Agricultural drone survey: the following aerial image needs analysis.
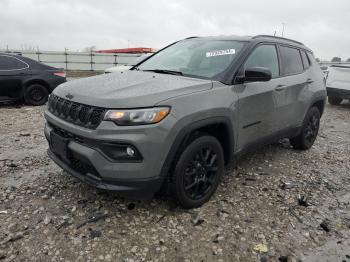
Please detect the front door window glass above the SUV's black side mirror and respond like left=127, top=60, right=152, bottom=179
left=244, top=45, right=279, bottom=78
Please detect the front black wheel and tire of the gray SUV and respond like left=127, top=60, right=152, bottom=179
left=169, top=135, right=224, bottom=208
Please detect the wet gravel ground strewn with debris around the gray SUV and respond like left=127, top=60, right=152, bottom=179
left=0, top=103, right=350, bottom=262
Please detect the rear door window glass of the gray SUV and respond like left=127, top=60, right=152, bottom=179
left=280, top=46, right=304, bottom=75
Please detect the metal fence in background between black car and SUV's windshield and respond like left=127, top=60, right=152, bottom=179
left=0, top=50, right=141, bottom=71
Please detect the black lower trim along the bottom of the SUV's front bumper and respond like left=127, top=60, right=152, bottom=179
left=47, top=149, right=163, bottom=199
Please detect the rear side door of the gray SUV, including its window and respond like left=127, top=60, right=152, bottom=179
left=275, top=45, right=313, bottom=132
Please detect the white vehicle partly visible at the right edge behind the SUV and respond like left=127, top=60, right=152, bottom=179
left=326, top=64, right=350, bottom=105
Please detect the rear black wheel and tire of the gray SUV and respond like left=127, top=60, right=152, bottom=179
left=290, top=107, right=321, bottom=150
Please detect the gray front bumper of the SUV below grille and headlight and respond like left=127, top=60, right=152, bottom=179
left=44, top=111, right=178, bottom=198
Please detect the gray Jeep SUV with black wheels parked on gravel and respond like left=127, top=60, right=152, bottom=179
left=45, top=36, right=326, bottom=208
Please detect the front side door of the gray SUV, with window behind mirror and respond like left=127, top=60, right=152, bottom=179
left=235, top=44, right=283, bottom=150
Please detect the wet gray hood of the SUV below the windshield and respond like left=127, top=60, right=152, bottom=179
left=53, top=71, right=212, bottom=108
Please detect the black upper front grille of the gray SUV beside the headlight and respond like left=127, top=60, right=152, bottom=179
left=48, top=94, right=105, bottom=129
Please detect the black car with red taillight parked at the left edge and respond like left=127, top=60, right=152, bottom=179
left=0, top=53, right=66, bottom=105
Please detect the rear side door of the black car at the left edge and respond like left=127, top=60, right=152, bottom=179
left=0, top=54, right=30, bottom=100
